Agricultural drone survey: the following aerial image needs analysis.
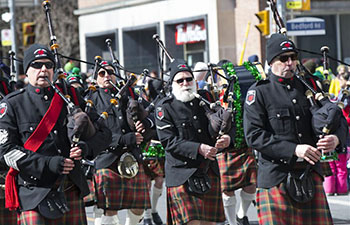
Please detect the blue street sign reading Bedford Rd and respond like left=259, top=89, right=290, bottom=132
left=287, top=17, right=326, bottom=36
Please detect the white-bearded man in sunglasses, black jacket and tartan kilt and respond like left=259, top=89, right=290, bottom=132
left=155, top=59, right=233, bottom=225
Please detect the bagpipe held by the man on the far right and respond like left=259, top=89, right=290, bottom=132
left=268, top=0, right=343, bottom=161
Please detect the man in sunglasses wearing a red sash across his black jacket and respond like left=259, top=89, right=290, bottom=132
left=0, top=44, right=111, bottom=224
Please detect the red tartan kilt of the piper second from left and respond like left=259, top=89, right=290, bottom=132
left=94, top=165, right=151, bottom=210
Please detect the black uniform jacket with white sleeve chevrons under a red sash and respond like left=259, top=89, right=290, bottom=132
left=0, top=85, right=111, bottom=210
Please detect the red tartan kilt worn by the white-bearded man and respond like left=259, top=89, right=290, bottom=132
left=167, top=169, right=225, bottom=224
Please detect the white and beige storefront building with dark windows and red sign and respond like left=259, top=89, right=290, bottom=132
left=75, top=0, right=261, bottom=72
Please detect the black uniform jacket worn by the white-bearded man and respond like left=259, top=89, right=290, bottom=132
left=155, top=90, right=227, bottom=187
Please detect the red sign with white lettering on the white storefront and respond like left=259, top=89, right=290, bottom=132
left=175, top=20, right=207, bottom=45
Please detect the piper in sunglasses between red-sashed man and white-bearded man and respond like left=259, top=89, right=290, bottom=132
left=87, top=61, right=155, bottom=225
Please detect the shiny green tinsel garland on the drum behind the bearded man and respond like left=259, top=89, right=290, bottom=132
left=223, top=62, right=261, bottom=149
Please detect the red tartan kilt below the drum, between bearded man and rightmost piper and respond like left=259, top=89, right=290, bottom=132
left=216, top=148, right=257, bottom=191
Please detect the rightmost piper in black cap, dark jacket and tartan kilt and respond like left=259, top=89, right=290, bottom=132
left=243, top=34, right=347, bottom=224
